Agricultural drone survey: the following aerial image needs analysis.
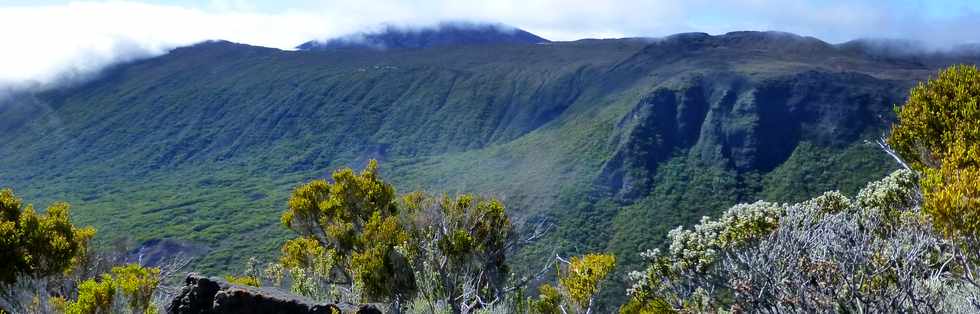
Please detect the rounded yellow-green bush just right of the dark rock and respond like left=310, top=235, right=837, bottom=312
left=281, top=160, right=415, bottom=301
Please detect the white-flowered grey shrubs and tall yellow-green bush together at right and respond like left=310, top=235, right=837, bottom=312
left=621, top=66, right=980, bottom=313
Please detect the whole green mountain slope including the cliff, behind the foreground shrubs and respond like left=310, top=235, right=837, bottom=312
left=0, top=32, right=968, bottom=280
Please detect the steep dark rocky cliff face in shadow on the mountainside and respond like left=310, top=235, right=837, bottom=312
left=598, top=71, right=907, bottom=201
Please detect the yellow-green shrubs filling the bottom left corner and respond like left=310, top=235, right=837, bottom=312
left=0, top=189, right=186, bottom=314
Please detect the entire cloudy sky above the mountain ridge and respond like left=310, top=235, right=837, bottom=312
left=0, top=0, right=980, bottom=91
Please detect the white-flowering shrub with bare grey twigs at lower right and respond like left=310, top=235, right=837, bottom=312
left=628, top=170, right=968, bottom=312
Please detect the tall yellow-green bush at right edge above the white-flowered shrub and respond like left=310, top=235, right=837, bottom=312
left=888, top=65, right=980, bottom=304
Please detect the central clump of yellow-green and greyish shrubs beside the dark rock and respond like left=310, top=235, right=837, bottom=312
left=228, top=161, right=615, bottom=313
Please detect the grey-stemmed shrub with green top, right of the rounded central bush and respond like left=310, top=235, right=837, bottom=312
left=401, top=192, right=514, bottom=313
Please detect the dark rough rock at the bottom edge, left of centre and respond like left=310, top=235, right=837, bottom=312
left=167, top=273, right=366, bottom=314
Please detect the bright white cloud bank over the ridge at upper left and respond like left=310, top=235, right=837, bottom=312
left=0, top=2, right=338, bottom=88
